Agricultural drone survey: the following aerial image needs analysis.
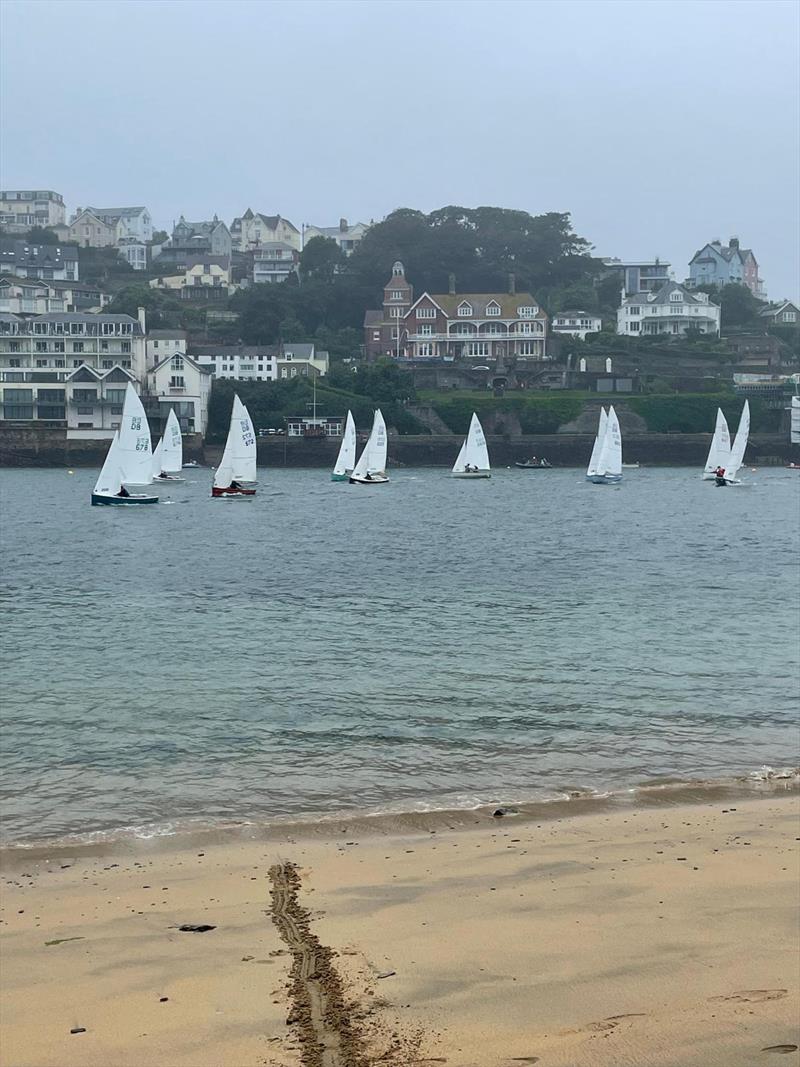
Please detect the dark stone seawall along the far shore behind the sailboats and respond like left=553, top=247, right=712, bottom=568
left=0, top=428, right=800, bottom=467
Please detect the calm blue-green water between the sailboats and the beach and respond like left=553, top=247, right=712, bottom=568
left=0, top=468, right=800, bottom=841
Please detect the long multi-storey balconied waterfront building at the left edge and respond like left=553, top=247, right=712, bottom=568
left=0, top=309, right=145, bottom=437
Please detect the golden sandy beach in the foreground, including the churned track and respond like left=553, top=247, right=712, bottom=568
left=0, top=793, right=800, bottom=1067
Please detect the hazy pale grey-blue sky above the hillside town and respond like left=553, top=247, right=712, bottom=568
left=0, top=0, right=800, bottom=299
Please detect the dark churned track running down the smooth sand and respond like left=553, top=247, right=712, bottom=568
left=269, top=863, right=369, bottom=1067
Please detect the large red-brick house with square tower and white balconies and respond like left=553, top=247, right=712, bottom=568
left=364, top=261, right=547, bottom=361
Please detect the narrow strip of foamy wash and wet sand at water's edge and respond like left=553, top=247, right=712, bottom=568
left=0, top=766, right=800, bottom=866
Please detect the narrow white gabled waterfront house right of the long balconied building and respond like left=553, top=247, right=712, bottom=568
left=143, top=349, right=212, bottom=434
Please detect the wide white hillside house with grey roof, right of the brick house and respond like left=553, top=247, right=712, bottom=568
left=617, top=282, right=720, bottom=337
